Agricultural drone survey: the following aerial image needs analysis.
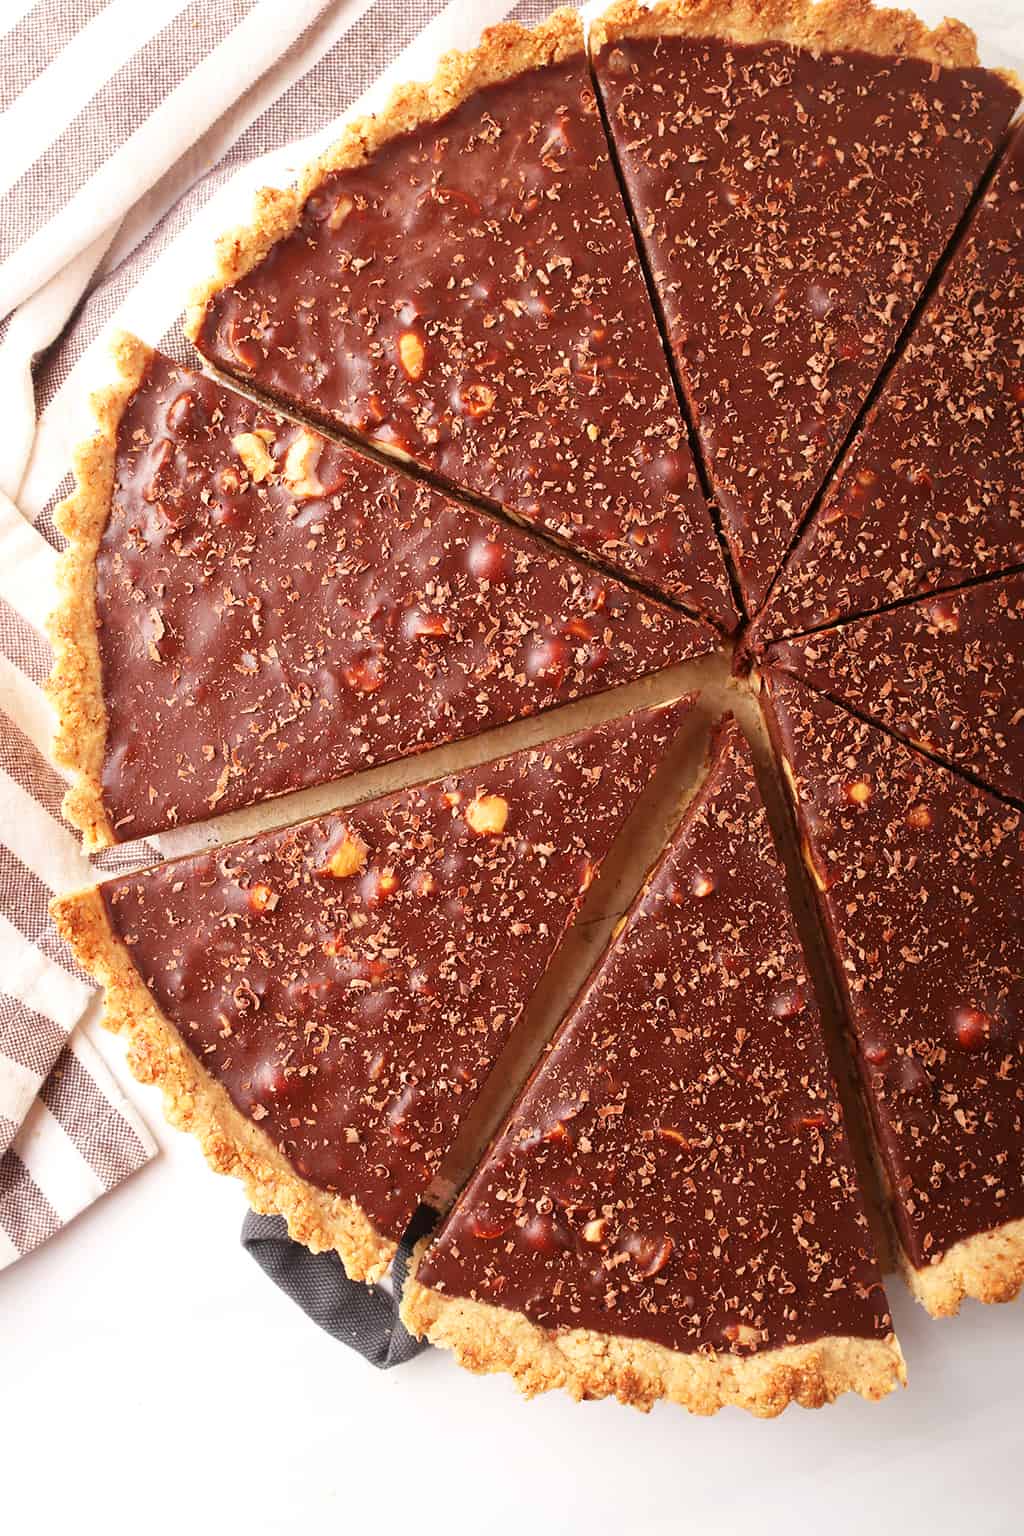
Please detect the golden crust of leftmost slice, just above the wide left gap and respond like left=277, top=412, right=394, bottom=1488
left=46, top=330, right=154, bottom=854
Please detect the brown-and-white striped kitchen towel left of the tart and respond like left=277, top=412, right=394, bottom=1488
left=0, top=0, right=577, bottom=1267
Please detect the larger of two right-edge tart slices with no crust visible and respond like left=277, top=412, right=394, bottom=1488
left=760, top=127, right=1024, bottom=636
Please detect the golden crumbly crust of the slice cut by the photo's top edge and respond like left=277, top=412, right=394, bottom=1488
left=590, top=0, right=978, bottom=69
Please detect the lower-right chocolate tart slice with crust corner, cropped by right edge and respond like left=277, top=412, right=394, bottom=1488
left=766, top=670, right=1024, bottom=1316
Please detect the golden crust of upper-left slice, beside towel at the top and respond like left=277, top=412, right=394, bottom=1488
left=184, top=8, right=585, bottom=344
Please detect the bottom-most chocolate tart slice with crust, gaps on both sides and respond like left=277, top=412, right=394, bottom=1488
left=402, top=722, right=904, bottom=1416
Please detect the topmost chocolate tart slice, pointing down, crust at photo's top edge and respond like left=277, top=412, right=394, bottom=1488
left=591, top=0, right=1018, bottom=614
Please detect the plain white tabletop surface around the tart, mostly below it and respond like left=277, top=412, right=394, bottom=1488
left=0, top=0, right=1024, bottom=1536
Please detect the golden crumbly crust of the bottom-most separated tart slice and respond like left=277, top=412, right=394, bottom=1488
left=401, top=1238, right=906, bottom=1419
